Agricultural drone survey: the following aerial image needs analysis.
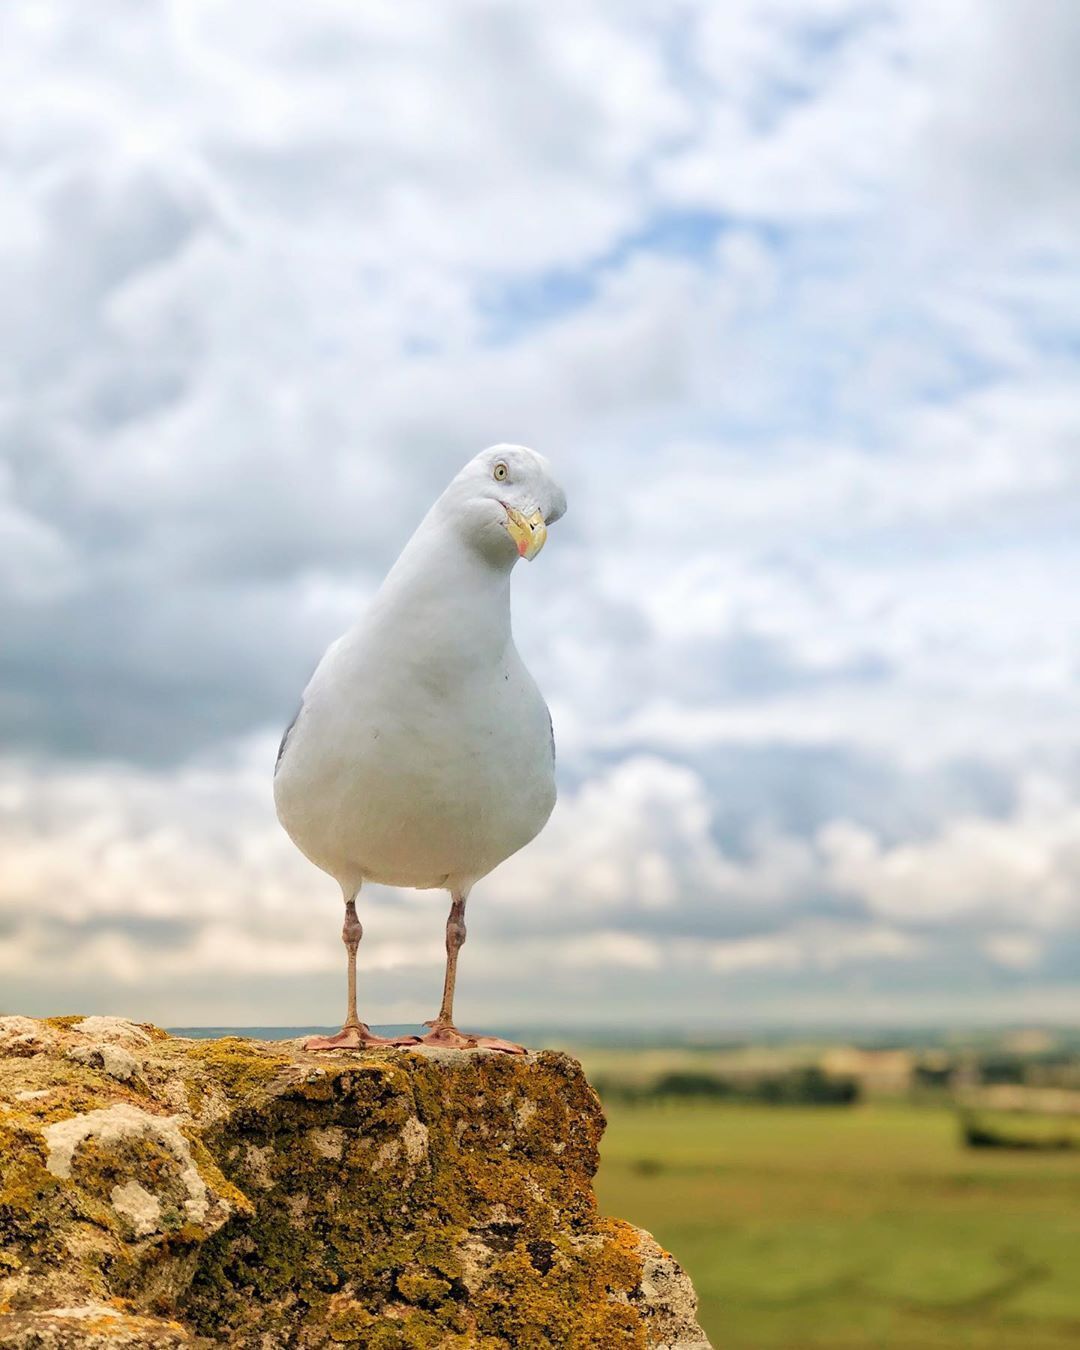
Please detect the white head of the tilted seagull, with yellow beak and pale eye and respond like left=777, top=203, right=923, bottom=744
left=444, top=446, right=566, bottom=566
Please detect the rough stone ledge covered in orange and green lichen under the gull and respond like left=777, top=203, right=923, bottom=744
left=0, top=1018, right=707, bottom=1350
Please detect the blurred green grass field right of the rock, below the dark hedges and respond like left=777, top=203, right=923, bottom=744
left=598, top=1104, right=1080, bottom=1350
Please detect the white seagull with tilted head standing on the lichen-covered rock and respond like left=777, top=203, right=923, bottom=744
left=274, top=446, right=566, bottom=1054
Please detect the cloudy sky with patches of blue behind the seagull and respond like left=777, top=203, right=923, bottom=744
left=0, top=0, right=1080, bottom=1031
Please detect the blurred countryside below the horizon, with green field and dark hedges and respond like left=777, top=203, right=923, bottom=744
left=173, top=1026, right=1080, bottom=1350
